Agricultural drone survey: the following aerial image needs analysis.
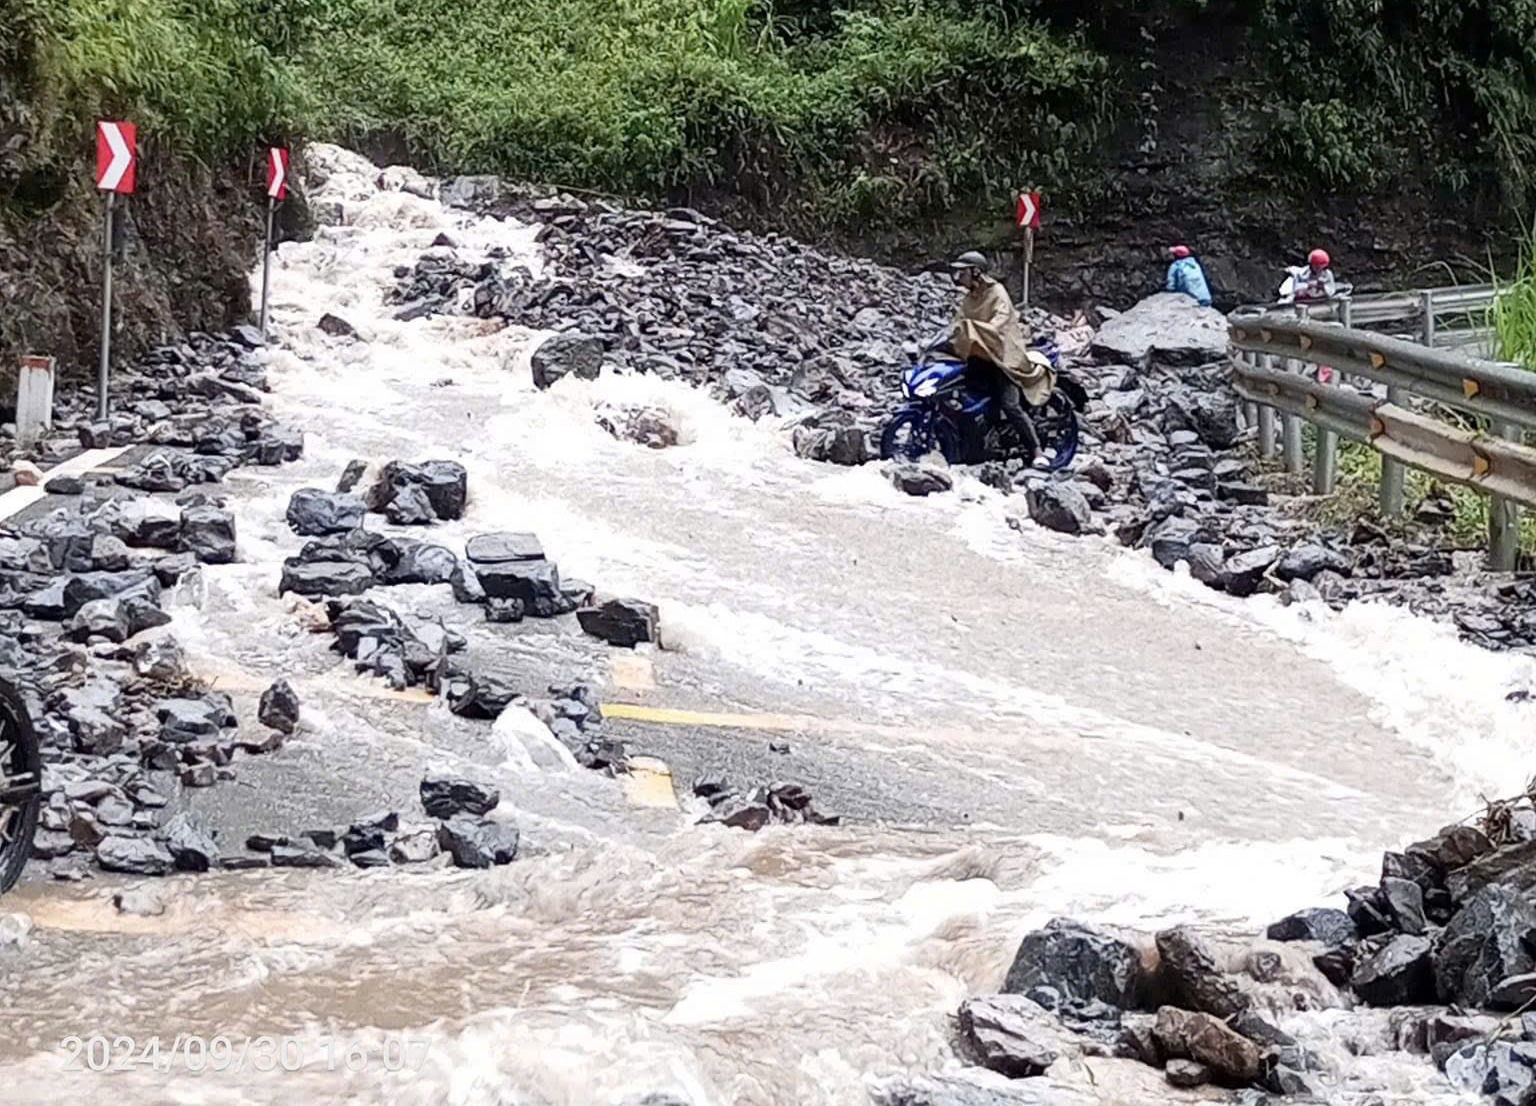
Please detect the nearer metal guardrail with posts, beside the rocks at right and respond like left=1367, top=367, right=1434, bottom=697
left=1229, top=315, right=1536, bottom=571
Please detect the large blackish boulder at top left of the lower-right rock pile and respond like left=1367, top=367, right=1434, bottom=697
left=1003, top=919, right=1143, bottom=1009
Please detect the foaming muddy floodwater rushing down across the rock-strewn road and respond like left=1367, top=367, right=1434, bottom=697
left=0, top=152, right=1533, bottom=1106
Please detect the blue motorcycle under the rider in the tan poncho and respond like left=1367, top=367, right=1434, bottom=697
left=880, top=329, right=1087, bottom=472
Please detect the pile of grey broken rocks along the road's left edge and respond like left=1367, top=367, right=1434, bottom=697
left=0, top=327, right=304, bottom=879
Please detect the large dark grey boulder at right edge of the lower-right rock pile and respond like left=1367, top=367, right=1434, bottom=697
left=1433, top=883, right=1536, bottom=1009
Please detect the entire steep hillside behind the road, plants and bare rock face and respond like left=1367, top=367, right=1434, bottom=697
left=0, top=0, right=1536, bottom=387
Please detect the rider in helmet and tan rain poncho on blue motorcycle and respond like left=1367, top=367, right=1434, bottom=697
left=949, top=250, right=1055, bottom=459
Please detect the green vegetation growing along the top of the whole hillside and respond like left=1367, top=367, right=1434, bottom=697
left=9, top=0, right=1536, bottom=227
